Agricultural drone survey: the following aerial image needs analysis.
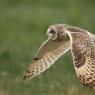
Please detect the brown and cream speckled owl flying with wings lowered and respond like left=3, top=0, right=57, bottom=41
left=24, top=24, right=95, bottom=88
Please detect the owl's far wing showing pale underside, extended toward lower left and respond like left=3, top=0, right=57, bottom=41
left=24, top=39, right=70, bottom=79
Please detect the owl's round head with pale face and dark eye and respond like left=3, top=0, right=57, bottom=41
left=46, top=24, right=68, bottom=40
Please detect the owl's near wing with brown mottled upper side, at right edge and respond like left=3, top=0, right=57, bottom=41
left=65, top=28, right=95, bottom=87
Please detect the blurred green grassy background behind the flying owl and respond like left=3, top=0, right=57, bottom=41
left=0, top=0, right=95, bottom=95
